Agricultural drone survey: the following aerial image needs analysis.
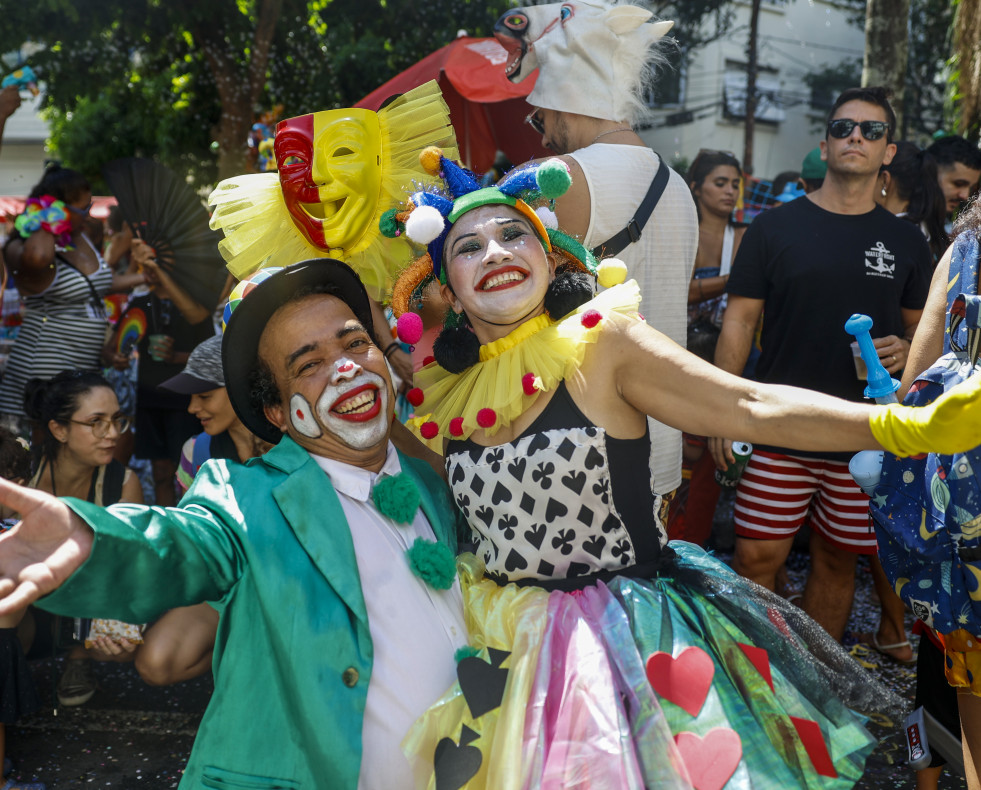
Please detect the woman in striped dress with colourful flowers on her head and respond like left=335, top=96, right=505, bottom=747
left=0, top=165, right=145, bottom=435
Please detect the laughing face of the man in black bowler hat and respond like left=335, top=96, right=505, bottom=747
left=259, top=294, right=394, bottom=463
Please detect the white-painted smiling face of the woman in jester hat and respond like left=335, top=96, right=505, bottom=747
left=442, top=205, right=554, bottom=342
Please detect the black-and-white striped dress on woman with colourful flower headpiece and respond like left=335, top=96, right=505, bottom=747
left=0, top=244, right=112, bottom=417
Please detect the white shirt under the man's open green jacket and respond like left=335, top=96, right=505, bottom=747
left=313, top=443, right=467, bottom=790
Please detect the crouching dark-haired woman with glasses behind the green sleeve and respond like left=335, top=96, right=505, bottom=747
left=24, top=370, right=143, bottom=705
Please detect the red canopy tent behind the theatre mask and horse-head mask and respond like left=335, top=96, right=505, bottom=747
left=357, top=37, right=548, bottom=173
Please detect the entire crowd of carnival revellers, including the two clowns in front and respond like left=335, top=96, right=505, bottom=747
left=0, top=4, right=981, bottom=790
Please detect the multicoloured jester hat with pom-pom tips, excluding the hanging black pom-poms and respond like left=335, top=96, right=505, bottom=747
left=379, top=146, right=626, bottom=344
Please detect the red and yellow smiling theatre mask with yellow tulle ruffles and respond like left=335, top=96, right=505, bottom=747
left=208, top=81, right=457, bottom=300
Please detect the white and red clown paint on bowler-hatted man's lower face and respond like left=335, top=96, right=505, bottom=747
left=290, top=357, right=392, bottom=450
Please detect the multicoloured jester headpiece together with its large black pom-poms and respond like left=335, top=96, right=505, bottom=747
left=381, top=147, right=626, bottom=373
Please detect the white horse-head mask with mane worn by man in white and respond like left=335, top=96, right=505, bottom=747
left=494, top=0, right=674, bottom=125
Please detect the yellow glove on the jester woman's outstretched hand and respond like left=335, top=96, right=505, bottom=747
left=869, top=376, right=981, bottom=456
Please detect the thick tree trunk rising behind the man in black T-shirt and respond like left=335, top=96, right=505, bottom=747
left=862, top=0, right=909, bottom=129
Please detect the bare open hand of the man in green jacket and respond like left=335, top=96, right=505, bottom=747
left=0, top=479, right=93, bottom=615
